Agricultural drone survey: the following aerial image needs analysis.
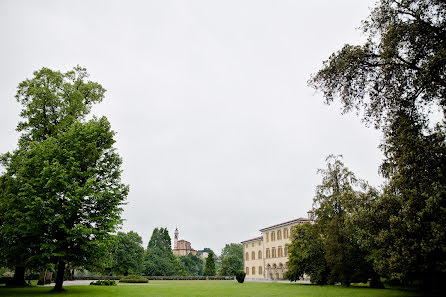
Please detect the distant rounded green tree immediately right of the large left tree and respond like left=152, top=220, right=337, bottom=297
left=106, top=231, right=144, bottom=275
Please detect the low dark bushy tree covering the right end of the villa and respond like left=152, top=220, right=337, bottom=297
left=285, top=224, right=329, bottom=285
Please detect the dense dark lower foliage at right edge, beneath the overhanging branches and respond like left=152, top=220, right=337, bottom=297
left=365, top=115, right=446, bottom=287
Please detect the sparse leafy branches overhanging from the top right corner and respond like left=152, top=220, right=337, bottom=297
left=309, top=0, right=446, bottom=126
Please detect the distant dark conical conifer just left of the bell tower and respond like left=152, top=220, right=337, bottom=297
left=143, top=228, right=186, bottom=276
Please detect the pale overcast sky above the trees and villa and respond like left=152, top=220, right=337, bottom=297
left=0, top=0, right=382, bottom=254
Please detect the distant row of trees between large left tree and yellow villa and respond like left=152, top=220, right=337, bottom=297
left=103, top=228, right=243, bottom=276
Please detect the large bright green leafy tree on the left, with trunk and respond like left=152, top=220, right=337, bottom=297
left=0, top=67, right=128, bottom=290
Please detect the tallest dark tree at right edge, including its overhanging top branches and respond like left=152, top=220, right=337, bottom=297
left=309, top=0, right=446, bottom=286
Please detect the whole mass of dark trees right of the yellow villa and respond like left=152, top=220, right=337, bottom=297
left=288, top=0, right=446, bottom=288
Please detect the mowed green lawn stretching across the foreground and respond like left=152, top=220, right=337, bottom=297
left=0, top=280, right=420, bottom=297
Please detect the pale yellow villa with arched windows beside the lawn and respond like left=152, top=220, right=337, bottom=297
left=241, top=218, right=311, bottom=280
